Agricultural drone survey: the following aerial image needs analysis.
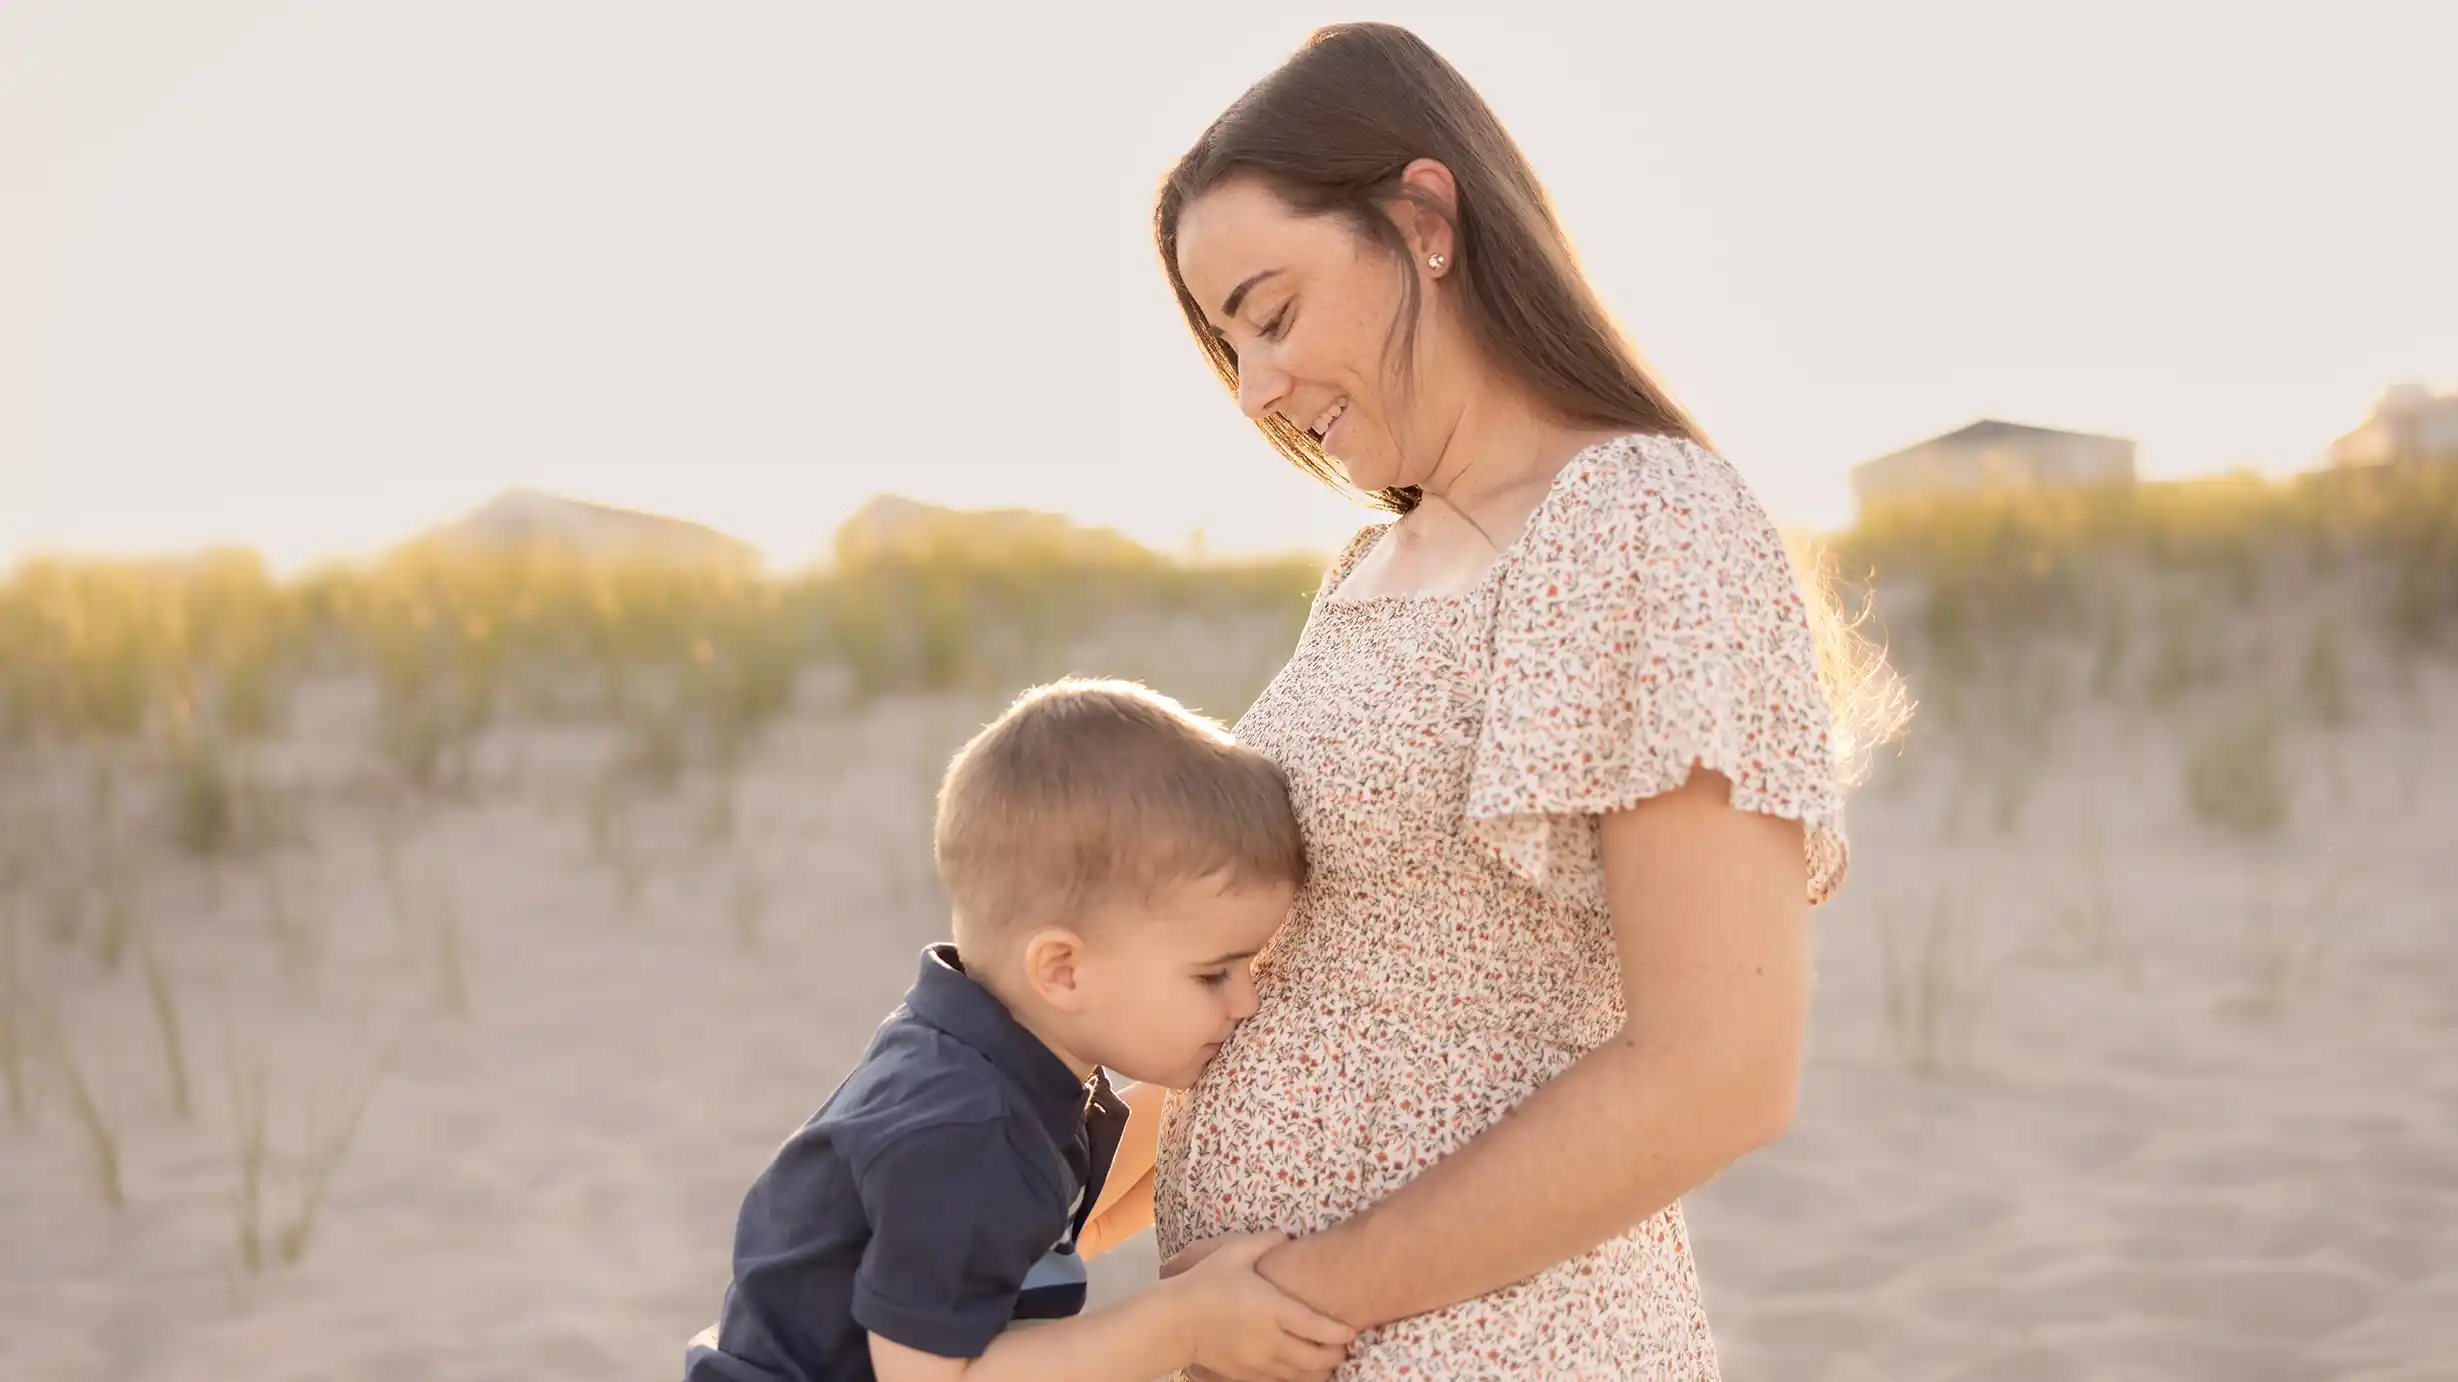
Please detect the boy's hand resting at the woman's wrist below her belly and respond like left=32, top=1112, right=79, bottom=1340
left=1165, top=1234, right=1357, bottom=1382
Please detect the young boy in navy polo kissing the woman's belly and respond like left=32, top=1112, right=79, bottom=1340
left=683, top=681, right=1352, bottom=1382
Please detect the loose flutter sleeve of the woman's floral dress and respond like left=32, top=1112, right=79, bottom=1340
left=1465, top=440, right=1848, bottom=905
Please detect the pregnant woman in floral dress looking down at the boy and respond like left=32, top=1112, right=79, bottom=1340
left=1155, top=25, right=1890, bottom=1380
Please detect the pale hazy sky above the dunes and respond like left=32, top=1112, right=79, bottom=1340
left=0, top=0, right=2458, bottom=568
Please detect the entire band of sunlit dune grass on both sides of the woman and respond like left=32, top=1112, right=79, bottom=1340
left=0, top=465, right=2458, bottom=959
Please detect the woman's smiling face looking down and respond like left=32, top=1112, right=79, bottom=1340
left=1177, top=180, right=1453, bottom=489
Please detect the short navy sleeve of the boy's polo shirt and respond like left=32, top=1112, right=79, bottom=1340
left=853, top=1124, right=1067, bottom=1357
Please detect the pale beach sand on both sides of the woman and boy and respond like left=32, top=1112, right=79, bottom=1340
left=0, top=649, right=2458, bottom=1382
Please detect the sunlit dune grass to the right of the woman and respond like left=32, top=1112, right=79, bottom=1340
left=1829, top=462, right=2458, bottom=839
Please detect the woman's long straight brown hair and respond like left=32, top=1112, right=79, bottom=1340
left=1153, top=25, right=1706, bottom=514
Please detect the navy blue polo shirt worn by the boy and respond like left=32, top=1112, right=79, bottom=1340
left=683, top=944, right=1126, bottom=1382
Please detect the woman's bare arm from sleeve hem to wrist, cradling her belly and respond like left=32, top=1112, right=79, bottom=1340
left=1258, top=770, right=1809, bottom=1328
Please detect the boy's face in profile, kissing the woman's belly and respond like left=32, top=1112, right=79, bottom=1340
left=1072, top=878, right=1295, bottom=1089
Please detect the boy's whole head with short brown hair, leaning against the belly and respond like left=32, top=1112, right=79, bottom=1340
left=934, top=679, right=1305, bottom=1087
